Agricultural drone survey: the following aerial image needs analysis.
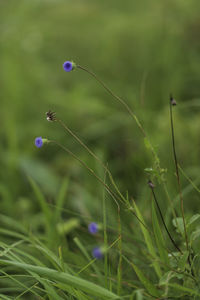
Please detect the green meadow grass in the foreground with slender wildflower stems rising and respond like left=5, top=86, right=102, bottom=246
left=0, top=61, right=200, bottom=299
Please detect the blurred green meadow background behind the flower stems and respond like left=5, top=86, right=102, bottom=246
left=0, top=0, right=200, bottom=227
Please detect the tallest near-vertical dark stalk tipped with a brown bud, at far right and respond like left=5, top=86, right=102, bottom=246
left=169, top=95, right=189, bottom=251
